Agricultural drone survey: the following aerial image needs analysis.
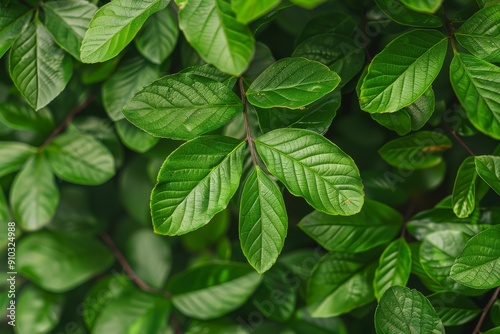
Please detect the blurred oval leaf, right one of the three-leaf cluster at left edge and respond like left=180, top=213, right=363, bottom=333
left=46, top=129, right=115, bottom=185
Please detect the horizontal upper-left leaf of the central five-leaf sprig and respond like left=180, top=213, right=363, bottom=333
left=123, top=74, right=243, bottom=139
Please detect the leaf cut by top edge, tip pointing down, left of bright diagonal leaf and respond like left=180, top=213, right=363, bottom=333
left=42, top=0, right=97, bottom=60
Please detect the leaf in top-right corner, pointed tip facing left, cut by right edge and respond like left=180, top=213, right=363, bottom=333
left=455, top=4, right=500, bottom=63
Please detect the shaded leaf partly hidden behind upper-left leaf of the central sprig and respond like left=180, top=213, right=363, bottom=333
left=101, top=56, right=161, bottom=122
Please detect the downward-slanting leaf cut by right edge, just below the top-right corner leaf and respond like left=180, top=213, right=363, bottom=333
left=450, top=52, right=500, bottom=139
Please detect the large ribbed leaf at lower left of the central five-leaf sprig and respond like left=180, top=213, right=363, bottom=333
left=151, top=136, right=246, bottom=235
